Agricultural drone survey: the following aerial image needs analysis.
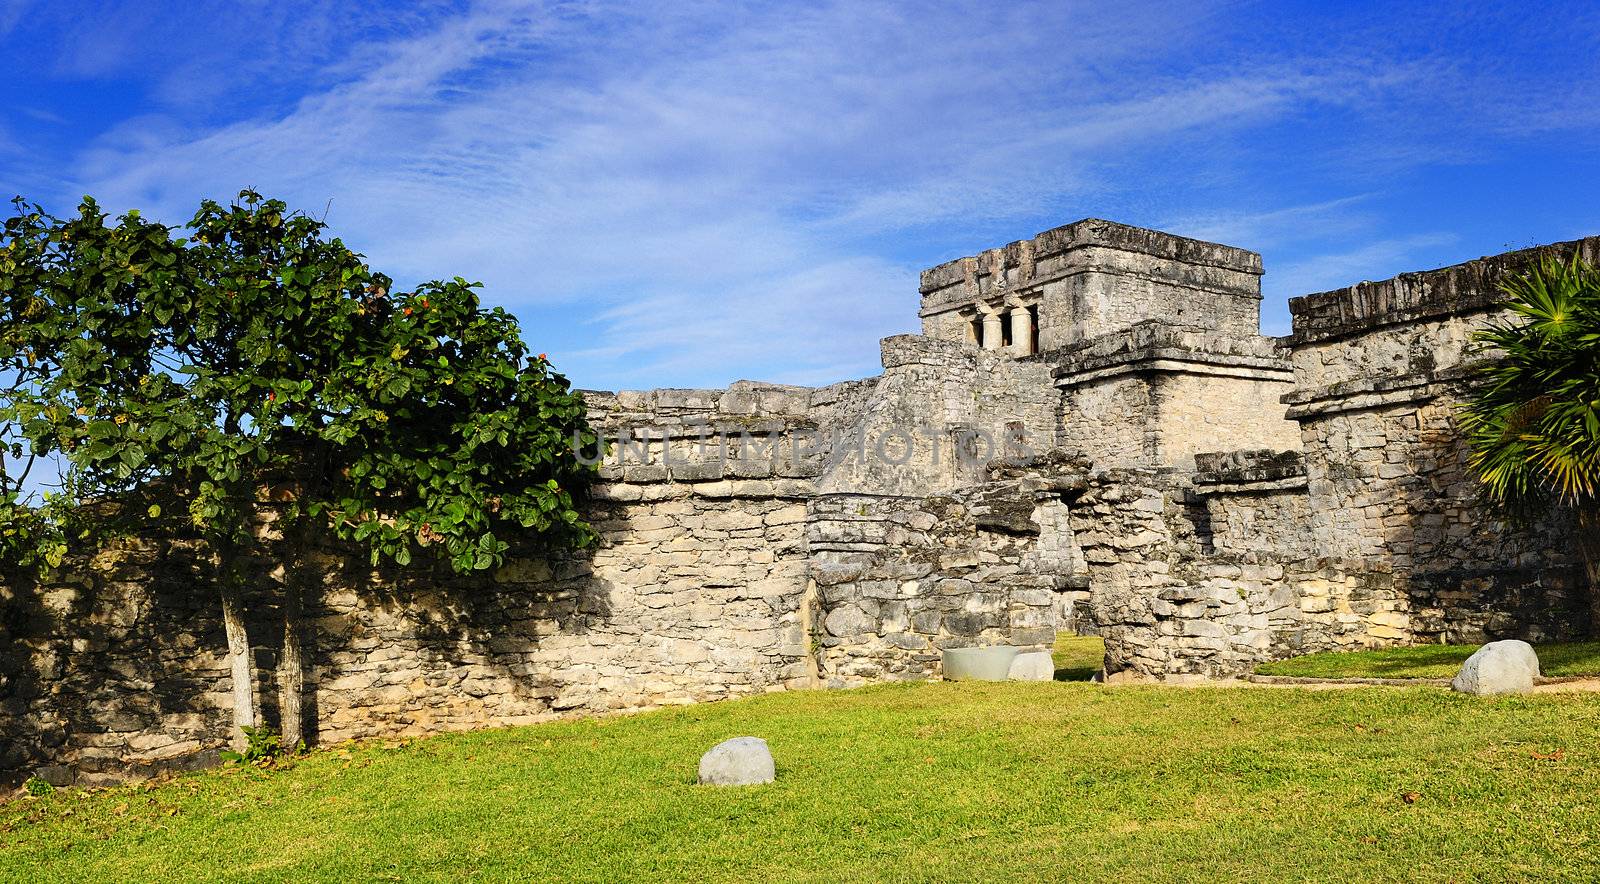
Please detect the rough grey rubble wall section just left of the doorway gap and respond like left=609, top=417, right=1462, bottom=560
left=808, top=479, right=1088, bottom=687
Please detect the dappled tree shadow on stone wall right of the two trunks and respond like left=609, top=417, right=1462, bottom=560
left=318, top=538, right=613, bottom=741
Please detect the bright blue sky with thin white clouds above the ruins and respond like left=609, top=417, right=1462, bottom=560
left=0, top=0, right=1600, bottom=389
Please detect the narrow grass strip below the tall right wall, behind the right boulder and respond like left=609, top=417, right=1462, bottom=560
left=1256, top=642, right=1600, bottom=679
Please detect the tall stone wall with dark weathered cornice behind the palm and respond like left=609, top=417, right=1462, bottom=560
left=1285, top=239, right=1600, bottom=605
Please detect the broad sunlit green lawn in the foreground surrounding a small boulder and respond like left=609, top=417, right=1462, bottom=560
left=0, top=682, right=1600, bottom=882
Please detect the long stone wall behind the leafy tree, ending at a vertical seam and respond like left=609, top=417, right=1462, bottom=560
left=0, top=384, right=832, bottom=783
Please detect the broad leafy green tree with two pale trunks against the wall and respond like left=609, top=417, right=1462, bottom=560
left=0, top=191, right=595, bottom=746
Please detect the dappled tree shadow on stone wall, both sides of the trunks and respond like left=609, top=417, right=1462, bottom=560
left=0, top=522, right=611, bottom=785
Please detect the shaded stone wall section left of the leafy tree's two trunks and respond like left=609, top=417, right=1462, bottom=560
left=0, top=541, right=229, bottom=783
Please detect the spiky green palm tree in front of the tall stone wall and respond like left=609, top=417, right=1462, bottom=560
left=1462, top=255, right=1600, bottom=629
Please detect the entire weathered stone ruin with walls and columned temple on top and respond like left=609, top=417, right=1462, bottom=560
left=0, top=219, right=1600, bottom=783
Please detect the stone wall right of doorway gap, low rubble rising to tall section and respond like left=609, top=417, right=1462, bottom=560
left=1064, top=239, right=1600, bottom=677
